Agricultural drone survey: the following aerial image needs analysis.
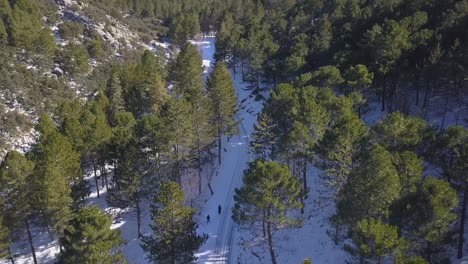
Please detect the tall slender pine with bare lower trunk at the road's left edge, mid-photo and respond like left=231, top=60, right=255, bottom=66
left=206, top=63, right=239, bottom=164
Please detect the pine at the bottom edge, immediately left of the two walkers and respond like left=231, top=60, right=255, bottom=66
left=142, top=182, right=208, bottom=264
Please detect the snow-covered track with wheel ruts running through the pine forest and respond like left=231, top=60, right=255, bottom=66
left=192, top=38, right=262, bottom=264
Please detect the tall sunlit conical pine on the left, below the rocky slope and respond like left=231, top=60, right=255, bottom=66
left=34, top=115, right=80, bottom=244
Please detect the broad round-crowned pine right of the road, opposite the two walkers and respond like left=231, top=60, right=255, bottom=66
left=232, top=161, right=302, bottom=264
